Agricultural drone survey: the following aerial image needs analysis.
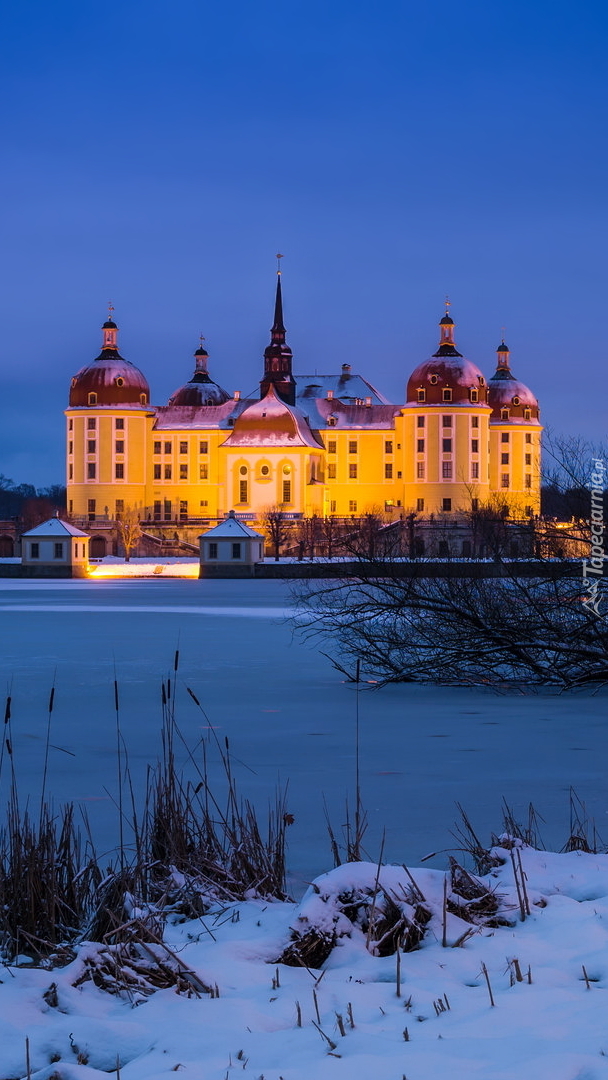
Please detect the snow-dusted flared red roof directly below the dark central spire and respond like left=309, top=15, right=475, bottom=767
left=224, top=384, right=322, bottom=450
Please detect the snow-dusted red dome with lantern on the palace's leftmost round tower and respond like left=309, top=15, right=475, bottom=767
left=69, top=314, right=150, bottom=408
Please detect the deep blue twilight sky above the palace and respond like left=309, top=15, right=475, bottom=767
left=0, top=0, right=608, bottom=485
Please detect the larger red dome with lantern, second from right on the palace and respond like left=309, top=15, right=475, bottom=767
left=407, top=309, right=487, bottom=406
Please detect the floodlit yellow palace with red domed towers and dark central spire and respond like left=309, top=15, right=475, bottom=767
left=66, top=272, right=542, bottom=530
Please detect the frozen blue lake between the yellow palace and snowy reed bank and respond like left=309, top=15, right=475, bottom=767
left=0, top=580, right=608, bottom=879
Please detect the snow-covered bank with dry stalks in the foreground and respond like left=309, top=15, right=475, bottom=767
left=0, top=848, right=608, bottom=1080
